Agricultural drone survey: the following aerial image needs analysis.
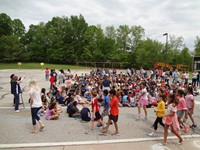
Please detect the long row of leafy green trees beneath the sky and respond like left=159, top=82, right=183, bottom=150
left=0, top=13, right=194, bottom=69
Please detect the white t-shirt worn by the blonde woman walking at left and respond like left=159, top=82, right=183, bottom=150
left=29, top=88, right=42, bottom=108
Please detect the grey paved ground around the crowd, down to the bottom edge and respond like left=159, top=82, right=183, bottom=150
left=0, top=70, right=200, bottom=150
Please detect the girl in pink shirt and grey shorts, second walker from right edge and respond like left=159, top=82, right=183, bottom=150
left=176, top=89, right=189, bottom=133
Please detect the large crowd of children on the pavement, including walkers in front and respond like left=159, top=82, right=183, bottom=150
left=27, top=68, right=198, bottom=144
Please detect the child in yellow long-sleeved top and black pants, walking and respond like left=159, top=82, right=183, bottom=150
left=149, top=94, right=165, bottom=136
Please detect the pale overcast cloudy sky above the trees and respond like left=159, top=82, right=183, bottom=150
left=0, top=0, right=200, bottom=50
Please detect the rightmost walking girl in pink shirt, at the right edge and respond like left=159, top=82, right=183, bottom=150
left=185, top=86, right=197, bottom=128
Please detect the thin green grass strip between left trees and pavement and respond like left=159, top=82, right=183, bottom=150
left=0, top=63, right=87, bottom=70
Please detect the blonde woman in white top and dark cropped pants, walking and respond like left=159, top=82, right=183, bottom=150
left=28, top=80, right=45, bottom=133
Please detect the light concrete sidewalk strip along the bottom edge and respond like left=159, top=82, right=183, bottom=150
left=1, top=138, right=200, bottom=150
